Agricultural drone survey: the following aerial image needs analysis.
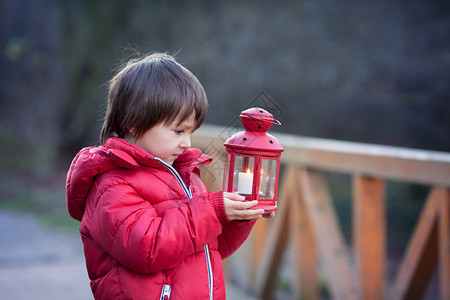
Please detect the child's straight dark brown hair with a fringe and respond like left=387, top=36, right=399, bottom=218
left=100, top=53, right=208, bottom=144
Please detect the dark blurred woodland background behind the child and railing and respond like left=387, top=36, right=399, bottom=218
left=0, top=0, right=450, bottom=258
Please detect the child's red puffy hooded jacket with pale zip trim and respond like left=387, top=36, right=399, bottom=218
left=66, top=138, right=254, bottom=300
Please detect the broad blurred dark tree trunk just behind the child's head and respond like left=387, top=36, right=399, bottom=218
left=58, top=1, right=133, bottom=161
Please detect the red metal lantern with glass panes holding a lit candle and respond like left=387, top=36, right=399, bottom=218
left=223, top=107, right=284, bottom=211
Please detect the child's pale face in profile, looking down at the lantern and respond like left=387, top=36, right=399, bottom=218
left=128, top=114, right=195, bottom=165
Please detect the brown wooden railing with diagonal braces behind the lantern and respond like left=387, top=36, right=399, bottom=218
left=192, top=125, right=450, bottom=300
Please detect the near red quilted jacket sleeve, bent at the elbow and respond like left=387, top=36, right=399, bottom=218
left=86, top=183, right=221, bottom=273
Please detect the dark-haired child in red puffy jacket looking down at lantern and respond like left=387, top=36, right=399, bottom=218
left=66, top=53, right=273, bottom=300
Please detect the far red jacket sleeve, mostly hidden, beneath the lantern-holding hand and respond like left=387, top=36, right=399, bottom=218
left=208, top=192, right=256, bottom=258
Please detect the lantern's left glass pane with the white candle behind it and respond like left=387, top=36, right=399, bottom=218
left=233, top=155, right=255, bottom=195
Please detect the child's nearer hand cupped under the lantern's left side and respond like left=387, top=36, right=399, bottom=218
left=223, top=192, right=264, bottom=221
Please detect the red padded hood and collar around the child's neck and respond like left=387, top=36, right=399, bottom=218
left=66, top=137, right=212, bottom=221
